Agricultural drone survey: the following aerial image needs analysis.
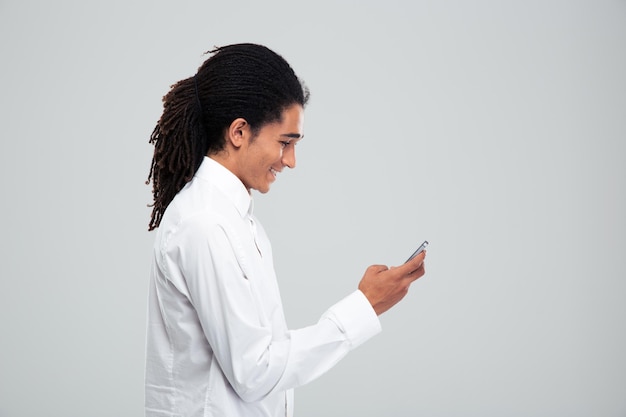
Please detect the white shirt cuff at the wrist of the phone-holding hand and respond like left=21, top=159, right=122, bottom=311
left=323, top=290, right=382, bottom=349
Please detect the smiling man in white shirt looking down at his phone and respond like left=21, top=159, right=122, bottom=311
left=146, top=44, right=425, bottom=417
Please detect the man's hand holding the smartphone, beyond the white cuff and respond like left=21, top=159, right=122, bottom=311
left=359, top=251, right=426, bottom=315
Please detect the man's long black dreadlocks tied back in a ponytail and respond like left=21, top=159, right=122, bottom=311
left=146, top=43, right=309, bottom=230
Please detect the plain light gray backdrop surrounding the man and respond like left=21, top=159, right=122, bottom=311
left=0, top=0, right=626, bottom=417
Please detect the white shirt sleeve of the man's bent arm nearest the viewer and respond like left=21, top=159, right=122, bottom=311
left=166, top=213, right=380, bottom=401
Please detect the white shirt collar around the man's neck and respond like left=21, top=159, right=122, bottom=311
left=194, top=156, right=254, bottom=217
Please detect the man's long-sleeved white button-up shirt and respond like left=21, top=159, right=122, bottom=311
left=145, top=157, right=380, bottom=417
